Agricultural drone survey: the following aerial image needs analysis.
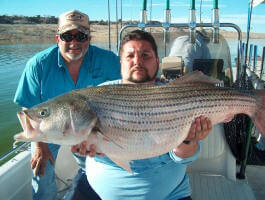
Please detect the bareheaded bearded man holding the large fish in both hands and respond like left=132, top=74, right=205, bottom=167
left=72, top=30, right=212, bottom=200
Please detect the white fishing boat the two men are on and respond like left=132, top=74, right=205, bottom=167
left=0, top=0, right=265, bottom=200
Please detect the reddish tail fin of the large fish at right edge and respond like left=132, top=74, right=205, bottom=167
left=252, top=89, right=265, bottom=137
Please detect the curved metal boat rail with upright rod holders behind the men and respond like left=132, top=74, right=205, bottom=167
left=113, top=0, right=242, bottom=81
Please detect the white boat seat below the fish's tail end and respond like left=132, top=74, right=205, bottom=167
left=187, top=124, right=255, bottom=200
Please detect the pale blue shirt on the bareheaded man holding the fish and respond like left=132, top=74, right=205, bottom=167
left=86, top=80, right=201, bottom=200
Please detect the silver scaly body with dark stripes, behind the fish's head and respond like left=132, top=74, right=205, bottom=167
left=75, top=84, right=256, bottom=159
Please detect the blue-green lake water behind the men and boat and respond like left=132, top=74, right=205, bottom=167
left=0, top=39, right=265, bottom=155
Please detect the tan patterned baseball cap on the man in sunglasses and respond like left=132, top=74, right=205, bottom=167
left=57, top=10, right=90, bottom=34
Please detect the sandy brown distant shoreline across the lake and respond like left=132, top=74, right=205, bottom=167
left=0, top=24, right=265, bottom=44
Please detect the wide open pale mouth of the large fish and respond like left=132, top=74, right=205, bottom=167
left=14, top=111, right=41, bottom=142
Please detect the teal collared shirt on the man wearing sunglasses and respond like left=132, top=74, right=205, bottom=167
left=14, top=45, right=120, bottom=108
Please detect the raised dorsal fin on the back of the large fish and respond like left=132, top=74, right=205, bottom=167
left=169, top=70, right=222, bottom=85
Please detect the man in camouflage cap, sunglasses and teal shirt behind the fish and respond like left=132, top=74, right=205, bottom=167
left=14, top=10, right=120, bottom=200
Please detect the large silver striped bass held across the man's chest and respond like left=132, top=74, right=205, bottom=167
left=14, top=72, right=265, bottom=171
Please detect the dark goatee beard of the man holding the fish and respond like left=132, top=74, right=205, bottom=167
left=128, top=66, right=158, bottom=83
